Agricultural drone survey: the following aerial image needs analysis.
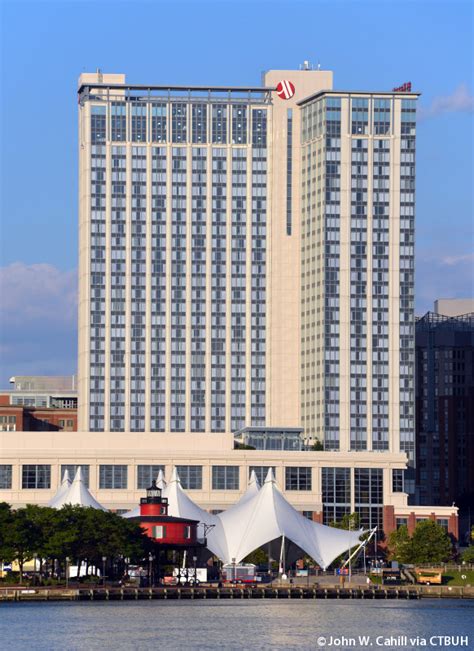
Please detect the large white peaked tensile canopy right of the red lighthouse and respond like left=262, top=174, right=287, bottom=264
left=124, top=468, right=363, bottom=568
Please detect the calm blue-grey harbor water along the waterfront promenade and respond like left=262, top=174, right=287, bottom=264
left=0, top=599, right=474, bottom=651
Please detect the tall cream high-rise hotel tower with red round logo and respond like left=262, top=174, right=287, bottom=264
left=78, top=69, right=417, bottom=455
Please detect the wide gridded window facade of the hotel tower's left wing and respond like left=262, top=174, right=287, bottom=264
left=89, top=97, right=267, bottom=432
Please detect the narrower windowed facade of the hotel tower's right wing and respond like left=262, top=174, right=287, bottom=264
left=301, top=94, right=416, bottom=457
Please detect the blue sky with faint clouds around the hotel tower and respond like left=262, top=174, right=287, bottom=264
left=0, top=0, right=474, bottom=386
